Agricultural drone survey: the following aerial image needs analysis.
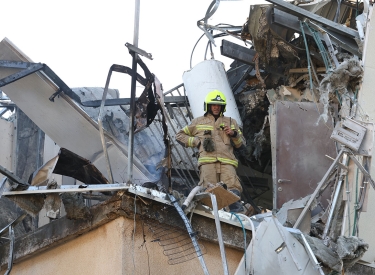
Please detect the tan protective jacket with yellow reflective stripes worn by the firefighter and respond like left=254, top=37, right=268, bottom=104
left=176, top=113, right=245, bottom=168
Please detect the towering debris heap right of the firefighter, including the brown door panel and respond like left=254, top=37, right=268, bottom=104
left=221, top=0, right=375, bottom=274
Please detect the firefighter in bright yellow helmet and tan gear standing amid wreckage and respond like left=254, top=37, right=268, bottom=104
left=176, top=90, right=245, bottom=213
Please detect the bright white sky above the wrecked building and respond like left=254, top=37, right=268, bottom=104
left=0, top=0, right=266, bottom=97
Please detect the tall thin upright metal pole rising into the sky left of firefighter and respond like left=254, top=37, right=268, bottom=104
left=127, top=0, right=140, bottom=184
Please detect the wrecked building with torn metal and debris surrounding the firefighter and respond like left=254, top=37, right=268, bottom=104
left=0, top=0, right=375, bottom=275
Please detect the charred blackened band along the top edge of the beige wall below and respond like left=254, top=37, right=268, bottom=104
left=0, top=192, right=251, bottom=266
